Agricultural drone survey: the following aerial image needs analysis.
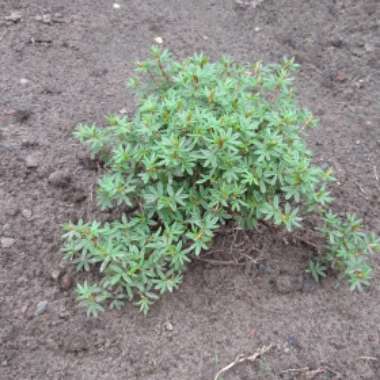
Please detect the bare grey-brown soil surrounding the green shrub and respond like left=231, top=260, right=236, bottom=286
left=0, top=0, right=380, bottom=380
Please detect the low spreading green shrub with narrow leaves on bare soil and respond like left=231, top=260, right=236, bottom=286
left=64, top=48, right=380, bottom=315
